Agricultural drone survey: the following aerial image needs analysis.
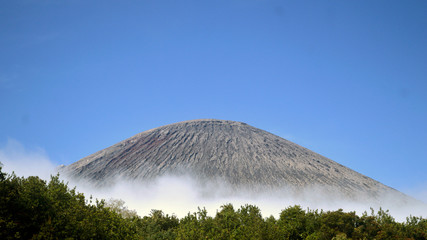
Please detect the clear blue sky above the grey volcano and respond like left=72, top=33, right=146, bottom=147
left=0, top=0, right=427, bottom=198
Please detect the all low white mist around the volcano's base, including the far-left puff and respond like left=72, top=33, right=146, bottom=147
left=0, top=140, right=427, bottom=221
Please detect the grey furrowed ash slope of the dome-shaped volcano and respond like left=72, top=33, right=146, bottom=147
left=63, top=119, right=404, bottom=201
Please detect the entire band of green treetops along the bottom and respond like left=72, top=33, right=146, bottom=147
left=0, top=165, right=427, bottom=240
